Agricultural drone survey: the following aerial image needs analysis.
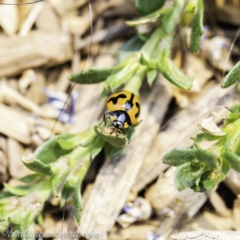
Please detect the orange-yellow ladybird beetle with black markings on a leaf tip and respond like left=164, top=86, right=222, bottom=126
left=103, top=90, right=140, bottom=135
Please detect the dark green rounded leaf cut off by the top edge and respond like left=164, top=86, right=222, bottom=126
left=135, top=0, right=166, bottom=15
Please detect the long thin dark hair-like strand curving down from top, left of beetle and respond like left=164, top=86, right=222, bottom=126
left=49, top=0, right=93, bottom=138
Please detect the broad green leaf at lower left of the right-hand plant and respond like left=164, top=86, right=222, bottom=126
left=174, top=162, right=207, bottom=191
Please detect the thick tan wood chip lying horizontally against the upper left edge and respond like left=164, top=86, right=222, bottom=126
left=0, top=31, right=72, bottom=77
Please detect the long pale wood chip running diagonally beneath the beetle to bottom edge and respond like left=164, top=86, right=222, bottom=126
left=79, top=78, right=171, bottom=239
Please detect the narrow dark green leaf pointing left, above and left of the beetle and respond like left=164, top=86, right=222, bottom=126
left=69, top=65, right=122, bottom=84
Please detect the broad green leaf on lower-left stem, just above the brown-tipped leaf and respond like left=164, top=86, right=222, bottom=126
left=34, top=135, right=70, bottom=164
